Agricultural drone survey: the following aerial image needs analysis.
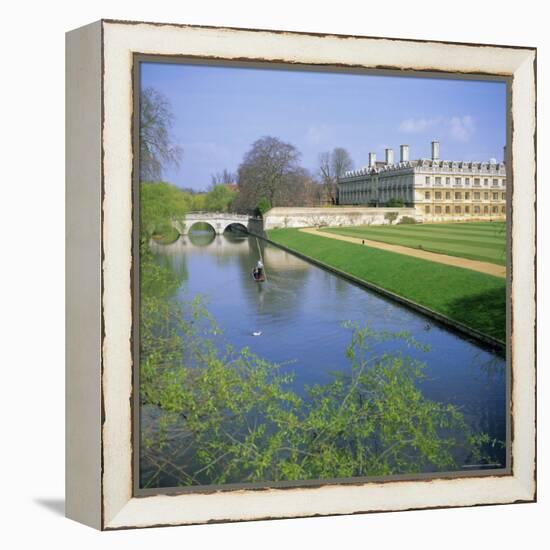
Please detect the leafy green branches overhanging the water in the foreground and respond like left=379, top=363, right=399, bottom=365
left=140, top=272, right=496, bottom=486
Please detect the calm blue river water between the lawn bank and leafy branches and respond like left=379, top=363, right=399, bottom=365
left=148, top=231, right=506, bottom=478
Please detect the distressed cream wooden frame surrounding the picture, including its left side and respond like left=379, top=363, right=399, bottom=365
left=66, top=20, right=536, bottom=530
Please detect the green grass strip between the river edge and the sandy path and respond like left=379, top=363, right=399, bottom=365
left=268, top=224, right=506, bottom=340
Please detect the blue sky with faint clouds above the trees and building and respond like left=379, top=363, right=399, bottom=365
left=141, top=63, right=506, bottom=190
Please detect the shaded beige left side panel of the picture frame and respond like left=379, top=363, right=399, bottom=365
left=65, top=21, right=103, bottom=529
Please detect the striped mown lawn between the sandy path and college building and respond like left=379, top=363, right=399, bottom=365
left=323, top=222, right=506, bottom=265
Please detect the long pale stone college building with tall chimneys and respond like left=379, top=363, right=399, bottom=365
left=338, top=141, right=506, bottom=222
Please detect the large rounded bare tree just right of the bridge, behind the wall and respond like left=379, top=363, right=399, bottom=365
left=234, top=136, right=304, bottom=215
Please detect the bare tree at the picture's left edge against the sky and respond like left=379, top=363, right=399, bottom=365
left=139, top=88, right=183, bottom=181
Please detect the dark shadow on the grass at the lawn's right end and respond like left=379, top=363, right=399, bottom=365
left=447, top=288, right=506, bottom=341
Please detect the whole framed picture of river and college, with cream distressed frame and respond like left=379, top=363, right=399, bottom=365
left=66, top=20, right=536, bottom=530
